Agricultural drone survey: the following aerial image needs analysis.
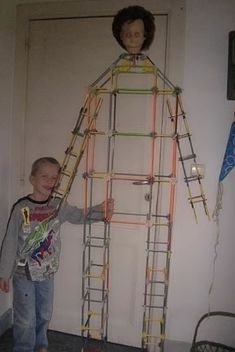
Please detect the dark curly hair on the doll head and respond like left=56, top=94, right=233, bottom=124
left=112, top=5, right=155, bottom=50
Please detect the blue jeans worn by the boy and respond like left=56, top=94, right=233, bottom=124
left=13, top=275, right=54, bottom=352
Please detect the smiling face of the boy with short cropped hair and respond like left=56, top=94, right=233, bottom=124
left=30, top=162, right=59, bottom=201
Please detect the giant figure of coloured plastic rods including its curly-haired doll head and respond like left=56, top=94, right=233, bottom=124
left=49, top=6, right=209, bottom=351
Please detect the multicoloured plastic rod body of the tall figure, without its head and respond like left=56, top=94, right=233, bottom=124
left=62, top=50, right=213, bottom=351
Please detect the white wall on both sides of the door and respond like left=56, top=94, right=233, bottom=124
left=0, top=0, right=235, bottom=342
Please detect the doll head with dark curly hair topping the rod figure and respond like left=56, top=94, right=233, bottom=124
left=112, top=6, right=155, bottom=54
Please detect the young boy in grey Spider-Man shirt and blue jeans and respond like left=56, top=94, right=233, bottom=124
left=0, top=157, right=113, bottom=352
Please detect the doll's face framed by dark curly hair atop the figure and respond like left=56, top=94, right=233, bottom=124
left=120, top=19, right=145, bottom=54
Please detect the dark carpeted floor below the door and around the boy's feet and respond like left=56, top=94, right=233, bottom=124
left=0, top=330, right=141, bottom=352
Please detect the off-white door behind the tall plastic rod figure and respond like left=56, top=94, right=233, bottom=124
left=13, top=0, right=185, bottom=346
